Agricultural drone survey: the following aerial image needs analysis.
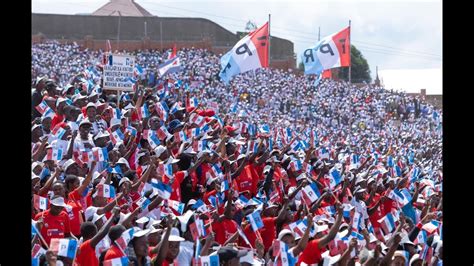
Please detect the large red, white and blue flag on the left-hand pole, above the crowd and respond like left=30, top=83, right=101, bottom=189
left=219, top=22, right=269, bottom=84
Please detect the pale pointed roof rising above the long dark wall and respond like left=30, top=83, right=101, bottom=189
left=92, top=0, right=154, bottom=17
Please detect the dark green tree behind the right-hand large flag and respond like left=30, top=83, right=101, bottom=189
left=338, top=45, right=372, bottom=83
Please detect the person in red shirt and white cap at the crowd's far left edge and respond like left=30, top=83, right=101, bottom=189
left=34, top=196, right=71, bottom=245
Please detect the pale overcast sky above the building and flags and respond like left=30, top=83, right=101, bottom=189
left=32, top=0, right=442, bottom=93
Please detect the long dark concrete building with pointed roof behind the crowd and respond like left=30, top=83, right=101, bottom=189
left=31, top=0, right=296, bottom=69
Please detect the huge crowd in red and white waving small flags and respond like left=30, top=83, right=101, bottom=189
left=31, top=41, right=443, bottom=265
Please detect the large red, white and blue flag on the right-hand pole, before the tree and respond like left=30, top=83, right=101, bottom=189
left=301, top=27, right=351, bottom=75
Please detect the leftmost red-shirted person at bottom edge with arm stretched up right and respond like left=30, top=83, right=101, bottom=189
left=75, top=207, right=120, bottom=266
